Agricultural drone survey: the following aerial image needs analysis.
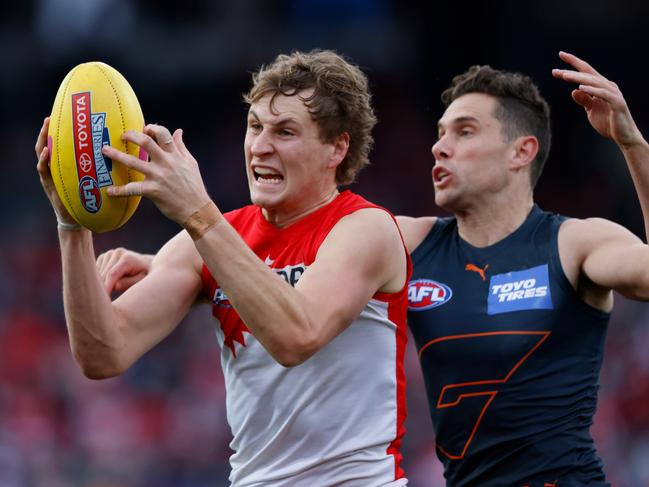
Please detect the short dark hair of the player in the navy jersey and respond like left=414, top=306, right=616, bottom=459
left=442, top=65, right=552, bottom=188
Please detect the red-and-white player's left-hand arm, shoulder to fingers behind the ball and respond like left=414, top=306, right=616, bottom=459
left=36, top=119, right=201, bottom=379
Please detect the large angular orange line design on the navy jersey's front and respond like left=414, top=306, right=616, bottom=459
left=419, top=331, right=551, bottom=460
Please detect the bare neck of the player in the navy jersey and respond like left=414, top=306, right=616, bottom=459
left=455, top=195, right=534, bottom=247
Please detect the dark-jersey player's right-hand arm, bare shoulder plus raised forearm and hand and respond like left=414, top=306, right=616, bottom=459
left=552, top=52, right=649, bottom=309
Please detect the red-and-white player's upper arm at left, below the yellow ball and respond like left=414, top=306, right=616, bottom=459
left=113, top=232, right=201, bottom=364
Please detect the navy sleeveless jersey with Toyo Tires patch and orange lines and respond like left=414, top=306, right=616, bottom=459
left=408, top=206, right=609, bottom=487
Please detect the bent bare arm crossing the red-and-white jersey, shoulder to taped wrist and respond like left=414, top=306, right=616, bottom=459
left=196, top=208, right=407, bottom=366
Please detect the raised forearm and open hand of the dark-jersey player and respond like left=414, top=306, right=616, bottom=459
left=552, top=52, right=649, bottom=238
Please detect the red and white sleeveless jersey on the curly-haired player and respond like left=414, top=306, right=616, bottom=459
left=203, top=191, right=411, bottom=487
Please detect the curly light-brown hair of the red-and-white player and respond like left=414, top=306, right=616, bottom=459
left=243, top=49, right=376, bottom=185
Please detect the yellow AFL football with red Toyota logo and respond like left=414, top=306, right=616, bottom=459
left=48, top=62, right=148, bottom=232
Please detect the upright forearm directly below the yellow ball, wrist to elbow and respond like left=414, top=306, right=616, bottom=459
left=59, top=230, right=124, bottom=378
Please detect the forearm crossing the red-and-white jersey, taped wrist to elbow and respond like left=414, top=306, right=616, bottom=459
left=195, top=215, right=315, bottom=365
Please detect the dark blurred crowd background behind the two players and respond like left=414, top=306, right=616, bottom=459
left=0, top=0, right=649, bottom=487
